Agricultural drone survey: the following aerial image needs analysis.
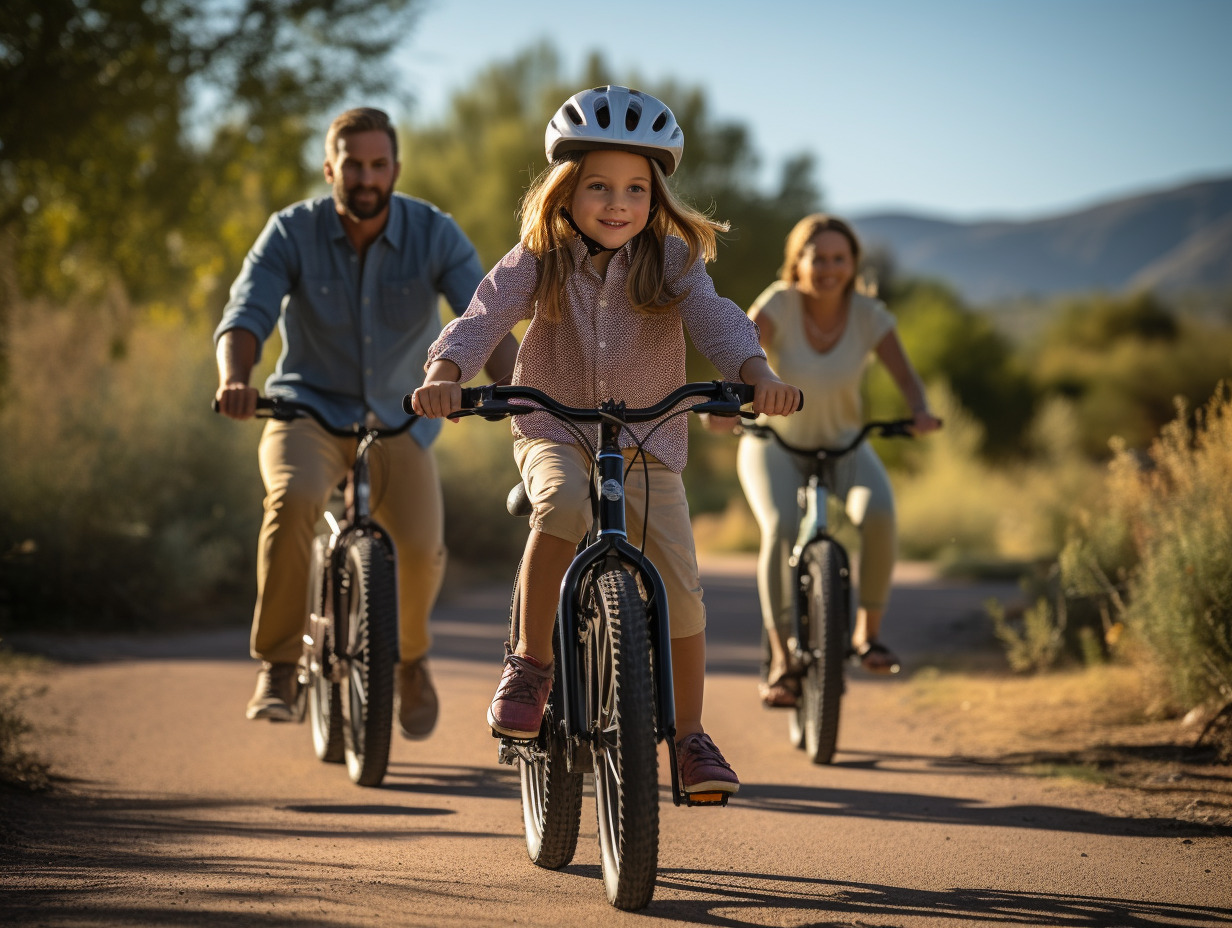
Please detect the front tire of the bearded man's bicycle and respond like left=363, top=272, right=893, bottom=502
left=338, top=535, right=398, bottom=786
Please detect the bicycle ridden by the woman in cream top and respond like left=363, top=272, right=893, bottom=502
left=743, top=419, right=913, bottom=764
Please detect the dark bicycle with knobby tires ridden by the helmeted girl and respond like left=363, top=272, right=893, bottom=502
left=404, top=381, right=753, bottom=910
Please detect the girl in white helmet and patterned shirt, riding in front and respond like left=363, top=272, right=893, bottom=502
left=413, top=86, right=800, bottom=792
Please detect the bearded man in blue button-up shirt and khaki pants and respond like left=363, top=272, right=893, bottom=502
left=214, top=107, right=517, bottom=738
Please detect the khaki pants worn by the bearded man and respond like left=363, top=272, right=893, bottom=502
left=251, top=419, right=445, bottom=663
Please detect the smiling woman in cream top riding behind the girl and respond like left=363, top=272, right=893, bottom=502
left=737, top=213, right=941, bottom=707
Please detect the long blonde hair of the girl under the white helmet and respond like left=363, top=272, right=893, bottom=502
left=520, top=152, right=728, bottom=322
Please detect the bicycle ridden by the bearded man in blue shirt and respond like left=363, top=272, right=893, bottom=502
left=214, top=397, right=418, bottom=786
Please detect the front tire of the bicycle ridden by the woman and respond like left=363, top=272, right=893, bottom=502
left=792, top=539, right=850, bottom=764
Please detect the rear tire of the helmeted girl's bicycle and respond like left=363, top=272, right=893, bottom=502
left=509, top=563, right=583, bottom=870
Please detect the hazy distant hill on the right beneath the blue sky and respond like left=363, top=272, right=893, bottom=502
left=851, top=177, right=1232, bottom=304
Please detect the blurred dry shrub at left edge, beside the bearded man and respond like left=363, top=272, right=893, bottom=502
left=0, top=304, right=260, bottom=627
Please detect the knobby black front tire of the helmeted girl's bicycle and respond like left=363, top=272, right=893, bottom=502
left=582, top=568, right=659, bottom=910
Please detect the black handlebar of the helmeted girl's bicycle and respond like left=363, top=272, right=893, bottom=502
left=402, top=381, right=783, bottom=424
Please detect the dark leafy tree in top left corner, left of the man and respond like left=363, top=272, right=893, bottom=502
left=0, top=0, right=419, bottom=377
